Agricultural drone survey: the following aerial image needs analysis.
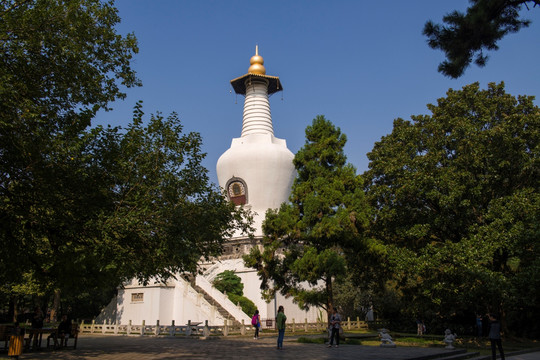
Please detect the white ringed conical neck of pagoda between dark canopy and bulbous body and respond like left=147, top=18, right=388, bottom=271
left=241, top=79, right=274, bottom=137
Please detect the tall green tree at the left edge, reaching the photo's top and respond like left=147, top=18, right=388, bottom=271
left=0, top=0, right=139, bottom=320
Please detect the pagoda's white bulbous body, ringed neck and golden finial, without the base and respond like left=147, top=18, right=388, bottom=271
left=217, top=48, right=296, bottom=237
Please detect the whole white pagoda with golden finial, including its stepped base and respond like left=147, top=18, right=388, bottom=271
left=97, top=47, right=325, bottom=325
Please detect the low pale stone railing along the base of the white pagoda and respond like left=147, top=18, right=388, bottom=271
left=79, top=318, right=368, bottom=338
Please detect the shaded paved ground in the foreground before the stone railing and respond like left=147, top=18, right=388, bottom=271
left=0, top=334, right=540, bottom=360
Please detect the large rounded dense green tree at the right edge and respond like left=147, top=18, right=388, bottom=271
left=364, top=83, right=540, bottom=334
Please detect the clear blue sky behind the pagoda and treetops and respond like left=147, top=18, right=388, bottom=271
left=94, top=0, right=540, bottom=183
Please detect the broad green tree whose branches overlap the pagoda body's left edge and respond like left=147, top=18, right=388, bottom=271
left=0, top=105, right=250, bottom=320
